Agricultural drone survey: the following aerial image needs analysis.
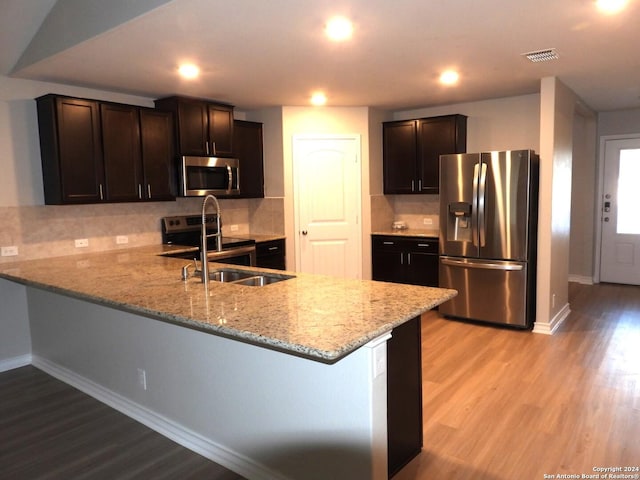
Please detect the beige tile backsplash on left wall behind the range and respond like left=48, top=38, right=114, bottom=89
left=0, top=198, right=284, bottom=263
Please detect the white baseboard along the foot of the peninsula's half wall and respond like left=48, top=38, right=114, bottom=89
left=31, top=355, right=286, bottom=480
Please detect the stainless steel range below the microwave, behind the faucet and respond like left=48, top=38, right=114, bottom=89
left=161, top=214, right=256, bottom=266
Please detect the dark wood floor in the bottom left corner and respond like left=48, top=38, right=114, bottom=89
left=0, top=366, right=243, bottom=480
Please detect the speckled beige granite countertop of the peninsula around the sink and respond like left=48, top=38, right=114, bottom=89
left=0, top=245, right=456, bottom=363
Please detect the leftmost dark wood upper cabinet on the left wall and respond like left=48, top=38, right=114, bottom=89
left=36, top=95, right=104, bottom=205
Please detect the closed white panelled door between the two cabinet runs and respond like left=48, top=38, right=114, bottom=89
left=293, top=135, right=362, bottom=278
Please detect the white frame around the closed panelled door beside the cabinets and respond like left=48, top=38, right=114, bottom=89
left=291, top=133, right=363, bottom=278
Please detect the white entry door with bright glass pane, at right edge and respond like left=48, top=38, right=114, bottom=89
left=600, top=138, right=640, bottom=285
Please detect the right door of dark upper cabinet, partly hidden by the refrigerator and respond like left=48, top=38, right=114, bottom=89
left=418, top=115, right=467, bottom=194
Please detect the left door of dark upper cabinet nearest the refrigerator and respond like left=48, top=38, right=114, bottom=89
left=382, top=120, right=417, bottom=194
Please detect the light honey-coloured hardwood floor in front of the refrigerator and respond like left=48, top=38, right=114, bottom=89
left=394, top=284, right=640, bottom=480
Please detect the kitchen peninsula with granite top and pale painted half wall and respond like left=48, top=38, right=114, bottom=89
left=0, top=246, right=455, bottom=480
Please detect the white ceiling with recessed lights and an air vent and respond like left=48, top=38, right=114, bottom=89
left=0, top=0, right=640, bottom=111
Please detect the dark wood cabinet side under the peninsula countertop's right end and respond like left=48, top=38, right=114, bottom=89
left=387, top=317, right=422, bottom=478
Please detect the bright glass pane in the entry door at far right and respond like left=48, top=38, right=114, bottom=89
left=616, top=148, right=640, bottom=234
